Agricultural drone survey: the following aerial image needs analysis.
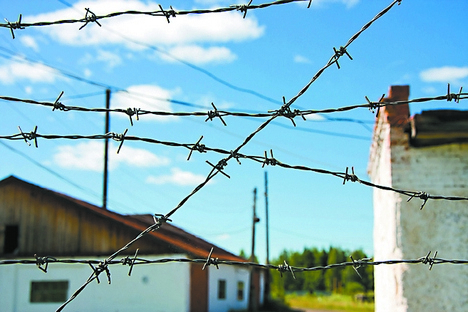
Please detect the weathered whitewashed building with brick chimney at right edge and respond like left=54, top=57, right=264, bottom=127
left=368, top=86, right=468, bottom=312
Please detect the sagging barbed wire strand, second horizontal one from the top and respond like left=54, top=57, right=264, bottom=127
left=0, top=84, right=468, bottom=126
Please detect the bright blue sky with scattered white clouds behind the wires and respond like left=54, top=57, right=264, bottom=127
left=0, top=0, right=468, bottom=261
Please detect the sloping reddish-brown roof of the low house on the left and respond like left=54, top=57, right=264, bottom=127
left=0, top=176, right=246, bottom=261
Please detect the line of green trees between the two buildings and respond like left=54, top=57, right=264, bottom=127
left=271, top=247, right=374, bottom=298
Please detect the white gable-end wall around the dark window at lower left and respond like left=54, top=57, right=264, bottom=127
left=0, top=255, right=190, bottom=312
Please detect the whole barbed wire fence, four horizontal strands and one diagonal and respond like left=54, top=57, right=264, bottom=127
left=0, top=0, right=468, bottom=311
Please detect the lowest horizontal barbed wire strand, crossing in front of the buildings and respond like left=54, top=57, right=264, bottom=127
left=0, top=250, right=468, bottom=276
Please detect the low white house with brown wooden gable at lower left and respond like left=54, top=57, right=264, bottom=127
left=0, top=176, right=262, bottom=312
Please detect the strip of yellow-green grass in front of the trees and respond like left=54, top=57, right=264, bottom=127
left=285, top=294, right=374, bottom=312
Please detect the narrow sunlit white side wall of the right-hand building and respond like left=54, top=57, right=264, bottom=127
left=368, top=114, right=407, bottom=312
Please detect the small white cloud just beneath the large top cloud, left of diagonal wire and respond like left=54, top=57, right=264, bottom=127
left=162, top=45, right=237, bottom=64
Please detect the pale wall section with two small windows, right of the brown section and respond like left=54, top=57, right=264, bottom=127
left=208, top=265, right=250, bottom=312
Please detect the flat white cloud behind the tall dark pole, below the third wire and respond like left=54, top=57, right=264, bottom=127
left=53, top=141, right=170, bottom=171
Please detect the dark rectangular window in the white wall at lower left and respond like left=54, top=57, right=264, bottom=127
left=29, top=281, right=68, bottom=302
